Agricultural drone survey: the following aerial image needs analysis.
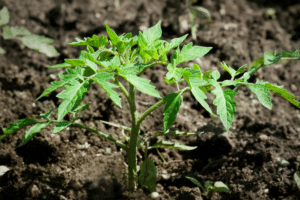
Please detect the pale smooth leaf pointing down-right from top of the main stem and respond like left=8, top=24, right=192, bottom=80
left=122, top=74, right=161, bottom=98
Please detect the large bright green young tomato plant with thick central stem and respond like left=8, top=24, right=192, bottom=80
left=0, top=21, right=300, bottom=192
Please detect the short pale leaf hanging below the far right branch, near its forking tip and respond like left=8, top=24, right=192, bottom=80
left=247, top=79, right=272, bottom=110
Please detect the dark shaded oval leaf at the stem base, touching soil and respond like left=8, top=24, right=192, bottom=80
left=139, top=158, right=157, bottom=192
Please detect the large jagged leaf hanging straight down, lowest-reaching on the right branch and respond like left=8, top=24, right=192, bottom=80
left=208, top=79, right=237, bottom=131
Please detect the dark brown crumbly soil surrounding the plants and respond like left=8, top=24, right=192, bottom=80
left=0, top=0, right=300, bottom=200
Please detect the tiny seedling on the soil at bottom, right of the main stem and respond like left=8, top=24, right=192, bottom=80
left=186, top=176, right=231, bottom=199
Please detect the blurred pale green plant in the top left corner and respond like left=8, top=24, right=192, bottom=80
left=0, top=7, right=59, bottom=57
